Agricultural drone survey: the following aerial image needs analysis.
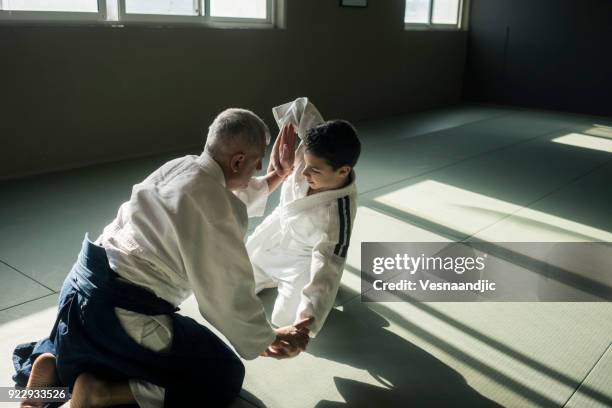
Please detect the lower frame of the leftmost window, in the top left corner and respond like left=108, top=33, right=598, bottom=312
left=0, top=0, right=107, bottom=23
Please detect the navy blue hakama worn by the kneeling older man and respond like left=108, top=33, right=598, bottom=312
left=13, top=237, right=244, bottom=407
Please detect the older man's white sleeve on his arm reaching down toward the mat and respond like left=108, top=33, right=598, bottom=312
left=180, top=196, right=276, bottom=359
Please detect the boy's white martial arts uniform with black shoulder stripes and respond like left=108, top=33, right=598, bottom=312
left=246, top=98, right=357, bottom=336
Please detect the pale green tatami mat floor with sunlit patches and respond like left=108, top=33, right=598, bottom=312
left=0, top=105, right=612, bottom=408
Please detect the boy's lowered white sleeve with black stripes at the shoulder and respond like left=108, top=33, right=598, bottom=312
left=297, top=204, right=350, bottom=337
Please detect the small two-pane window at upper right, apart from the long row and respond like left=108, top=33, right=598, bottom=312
left=404, top=0, right=467, bottom=29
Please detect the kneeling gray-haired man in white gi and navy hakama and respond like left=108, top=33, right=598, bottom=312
left=14, top=109, right=310, bottom=408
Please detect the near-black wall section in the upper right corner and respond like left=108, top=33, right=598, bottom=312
left=464, top=0, right=612, bottom=115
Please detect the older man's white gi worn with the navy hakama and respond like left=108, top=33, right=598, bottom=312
left=97, top=152, right=276, bottom=408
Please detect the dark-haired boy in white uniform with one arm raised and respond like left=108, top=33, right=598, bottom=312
left=247, top=98, right=361, bottom=336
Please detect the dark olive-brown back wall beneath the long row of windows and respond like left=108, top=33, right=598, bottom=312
left=0, top=0, right=467, bottom=179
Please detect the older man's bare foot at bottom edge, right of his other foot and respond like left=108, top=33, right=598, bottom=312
left=62, top=373, right=136, bottom=408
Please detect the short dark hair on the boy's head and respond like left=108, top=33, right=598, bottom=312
left=304, top=120, right=361, bottom=170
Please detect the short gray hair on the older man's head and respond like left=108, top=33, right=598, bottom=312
left=204, top=108, right=270, bottom=156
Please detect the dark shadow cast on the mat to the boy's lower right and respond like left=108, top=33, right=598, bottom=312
left=261, top=290, right=500, bottom=408
